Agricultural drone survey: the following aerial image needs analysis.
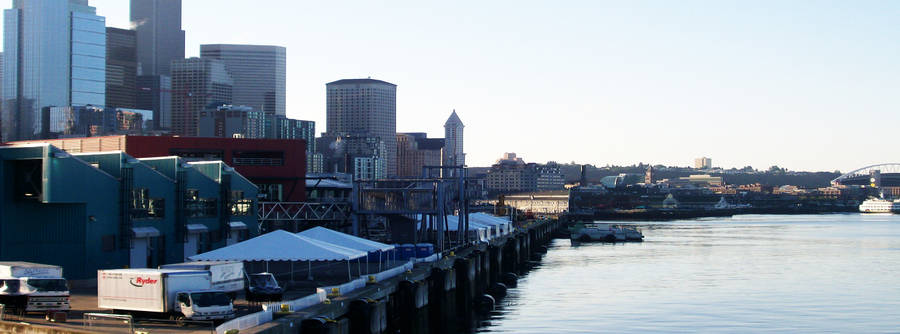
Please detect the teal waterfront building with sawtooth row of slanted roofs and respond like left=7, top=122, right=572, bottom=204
left=0, top=144, right=258, bottom=279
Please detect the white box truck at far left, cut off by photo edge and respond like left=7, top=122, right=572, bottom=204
left=0, top=262, right=69, bottom=318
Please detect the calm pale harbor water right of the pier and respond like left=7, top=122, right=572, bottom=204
left=479, top=214, right=900, bottom=333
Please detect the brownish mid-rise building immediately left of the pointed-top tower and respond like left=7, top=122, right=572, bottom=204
left=397, top=132, right=446, bottom=178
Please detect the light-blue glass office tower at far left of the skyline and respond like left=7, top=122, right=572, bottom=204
left=0, top=0, right=106, bottom=141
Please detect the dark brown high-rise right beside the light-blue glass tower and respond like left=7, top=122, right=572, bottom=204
left=106, top=27, right=137, bottom=108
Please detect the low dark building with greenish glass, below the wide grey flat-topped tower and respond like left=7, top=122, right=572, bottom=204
left=197, top=104, right=266, bottom=139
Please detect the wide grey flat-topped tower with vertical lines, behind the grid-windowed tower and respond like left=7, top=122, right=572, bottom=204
left=200, top=44, right=287, bottom=116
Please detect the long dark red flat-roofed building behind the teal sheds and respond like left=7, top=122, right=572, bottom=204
left=16, top=136, right=306, bottom=202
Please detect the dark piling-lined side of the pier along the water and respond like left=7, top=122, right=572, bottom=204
left=240, top=220, right=562, bottom=334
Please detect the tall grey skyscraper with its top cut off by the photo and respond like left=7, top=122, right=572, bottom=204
left=131, top=0, right=184, bottom=76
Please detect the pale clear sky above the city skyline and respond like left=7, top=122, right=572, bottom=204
left=5, top=0, right=900, bottom=171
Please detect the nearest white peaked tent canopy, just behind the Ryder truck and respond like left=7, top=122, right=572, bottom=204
left=190, top=230, right=368, bottom=261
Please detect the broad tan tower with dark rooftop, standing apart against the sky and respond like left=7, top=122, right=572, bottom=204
left=325, top=79, right=397, bottom=177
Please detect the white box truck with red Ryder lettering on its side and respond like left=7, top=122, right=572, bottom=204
left=97, top=269, right=235, bottom=325
